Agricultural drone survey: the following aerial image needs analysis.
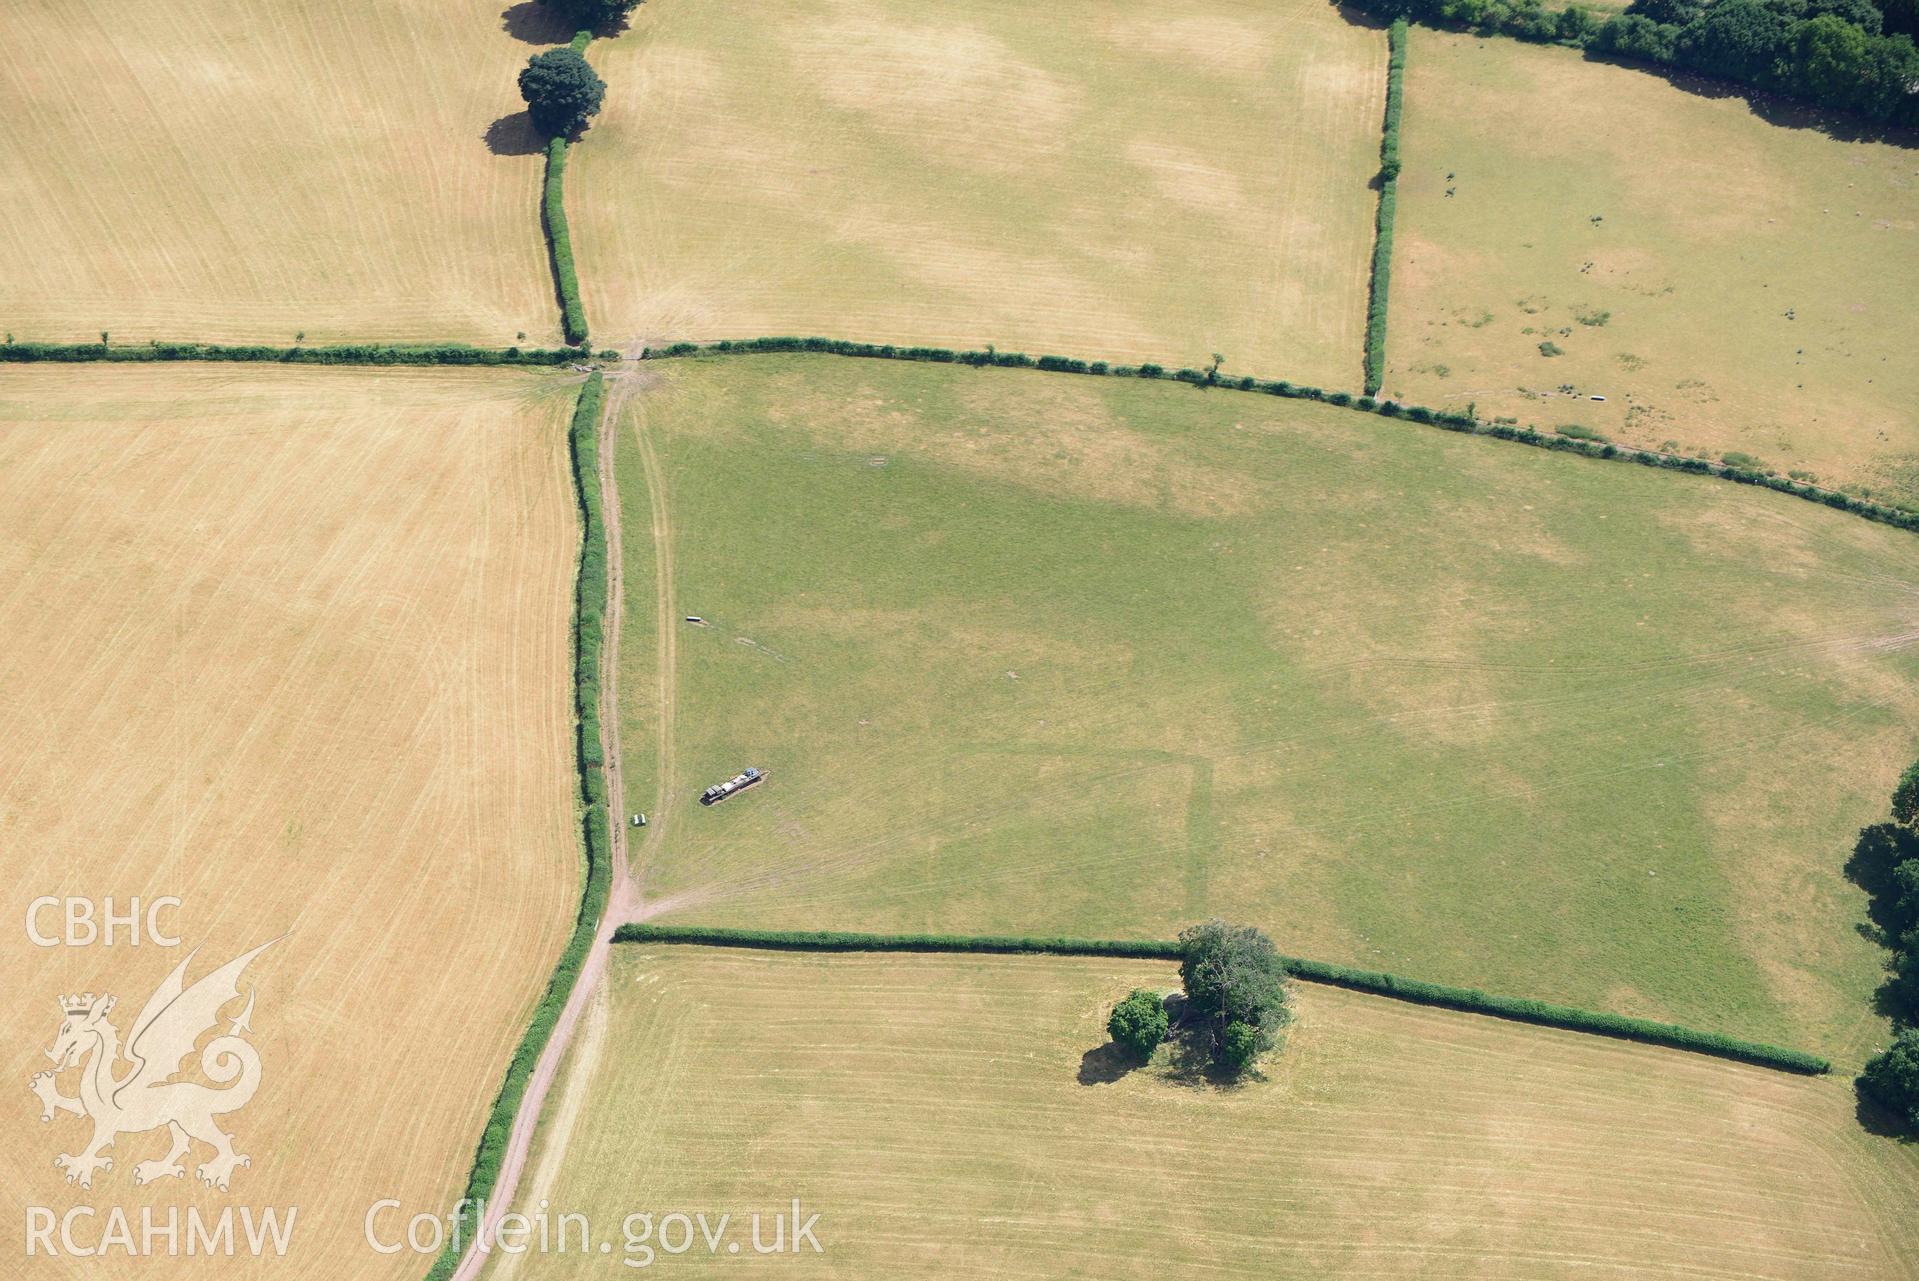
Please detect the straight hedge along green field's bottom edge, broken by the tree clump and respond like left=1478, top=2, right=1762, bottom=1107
left=612, top=924, right=1833, bottom=1076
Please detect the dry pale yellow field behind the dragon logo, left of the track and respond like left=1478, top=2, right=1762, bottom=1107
left=0, top=366, right=580, bottom=1281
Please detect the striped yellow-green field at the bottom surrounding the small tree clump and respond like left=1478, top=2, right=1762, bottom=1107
left=493, top=947, right=1919, bottom=1281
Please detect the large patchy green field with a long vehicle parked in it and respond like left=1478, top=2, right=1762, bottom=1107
left=620, top=357, right=1919, bottom=1060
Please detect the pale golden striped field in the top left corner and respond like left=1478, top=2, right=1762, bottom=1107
left=0, top=0, right=558, bottom=345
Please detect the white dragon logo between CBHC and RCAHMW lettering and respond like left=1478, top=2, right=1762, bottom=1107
left=31, top=940, right=280, bottom=1191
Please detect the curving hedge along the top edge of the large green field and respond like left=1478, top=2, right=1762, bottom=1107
left=639, top=338, right=1919, bottom=531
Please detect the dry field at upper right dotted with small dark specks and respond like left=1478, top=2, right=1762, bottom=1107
left=1386, top=29, right=1919, bottom=501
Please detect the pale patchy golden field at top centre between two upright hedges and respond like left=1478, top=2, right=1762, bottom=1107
left=568, top=0, right=1386, bottom=385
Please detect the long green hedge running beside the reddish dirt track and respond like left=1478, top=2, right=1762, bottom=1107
left=426, top=372, right=612, bottom=1281
